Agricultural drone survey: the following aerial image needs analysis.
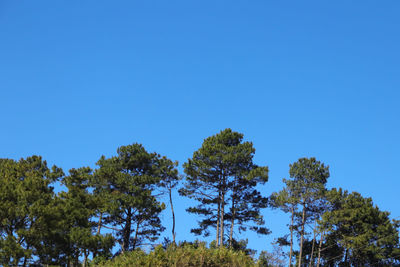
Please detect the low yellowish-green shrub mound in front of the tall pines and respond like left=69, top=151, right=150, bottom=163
left=95, top=243, right=257, bottom=267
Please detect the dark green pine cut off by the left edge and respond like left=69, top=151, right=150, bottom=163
left=0, top=156, right=63, bottom=265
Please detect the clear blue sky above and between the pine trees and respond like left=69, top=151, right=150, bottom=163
left=0, top=0, right=400, bottom=254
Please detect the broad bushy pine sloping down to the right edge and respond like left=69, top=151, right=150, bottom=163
left=320, top=189, right=400, bottom=266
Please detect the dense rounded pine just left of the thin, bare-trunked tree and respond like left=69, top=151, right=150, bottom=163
left=93, top=144, right=165, bottom=251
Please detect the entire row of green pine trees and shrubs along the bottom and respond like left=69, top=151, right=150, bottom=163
left=0, top=129, right=400, bottom=267
